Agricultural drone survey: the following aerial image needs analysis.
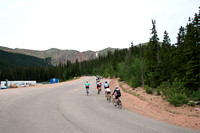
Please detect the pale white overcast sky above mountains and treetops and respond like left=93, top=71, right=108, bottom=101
left=0, top=0, right=200, bottom=52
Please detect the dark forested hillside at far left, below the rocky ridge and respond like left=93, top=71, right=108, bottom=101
left=0, top=50, right=51, bottom=68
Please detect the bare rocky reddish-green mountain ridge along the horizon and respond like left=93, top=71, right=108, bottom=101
left=0, top=46, right=115, bottom=65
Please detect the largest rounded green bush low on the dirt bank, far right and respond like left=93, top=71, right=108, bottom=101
left=167, top=93, right=189, bottom=107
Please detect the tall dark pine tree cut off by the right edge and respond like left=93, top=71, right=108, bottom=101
left=183, top=9, right=200, bottom=90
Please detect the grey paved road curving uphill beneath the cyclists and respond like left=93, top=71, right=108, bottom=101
left=0, top=77, right=198, bottom=133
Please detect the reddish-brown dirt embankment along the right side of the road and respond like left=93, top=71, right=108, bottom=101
left=110, top=79, right=200, bottom=131
